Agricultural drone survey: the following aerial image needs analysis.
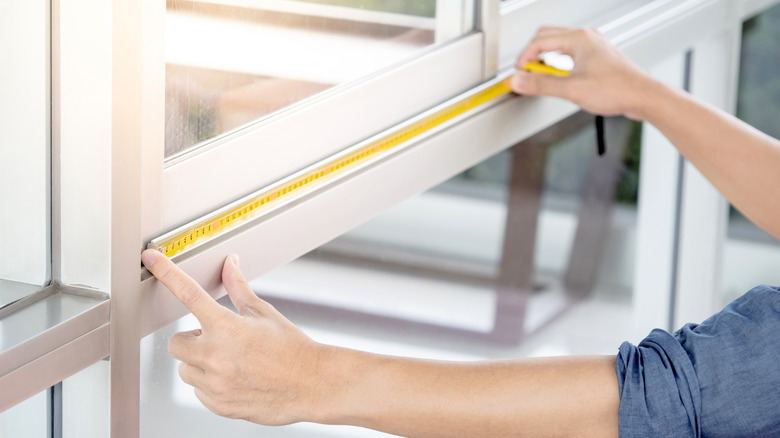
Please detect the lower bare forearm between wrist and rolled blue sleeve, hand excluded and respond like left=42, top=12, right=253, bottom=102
left=315, top=348, right=619, bottom=438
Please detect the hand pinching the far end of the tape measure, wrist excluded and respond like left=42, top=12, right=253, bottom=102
left=511, top=27, right=655, bottom=119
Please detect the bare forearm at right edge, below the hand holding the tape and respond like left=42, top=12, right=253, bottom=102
left=638, top=75, right=780, bottom=239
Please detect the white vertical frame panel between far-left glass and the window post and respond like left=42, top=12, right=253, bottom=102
left=57, top=0, right=111, bottom=292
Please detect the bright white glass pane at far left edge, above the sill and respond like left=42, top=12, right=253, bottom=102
left=0, top=1, right=51, bottom=294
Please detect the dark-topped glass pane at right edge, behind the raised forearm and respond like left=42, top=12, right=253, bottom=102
left=721, top=6, right=780, bottom=305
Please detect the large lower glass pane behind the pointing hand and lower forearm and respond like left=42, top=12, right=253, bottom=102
left=141, top=114, right=640, bottom=438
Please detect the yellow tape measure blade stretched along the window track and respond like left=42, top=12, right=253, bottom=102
left=148, top=72, right=512, bottom=257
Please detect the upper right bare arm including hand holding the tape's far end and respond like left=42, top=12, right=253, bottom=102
left=512, top=27, right=780, bottom=239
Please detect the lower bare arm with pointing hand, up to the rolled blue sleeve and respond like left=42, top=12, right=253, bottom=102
left=143, top=250, right=619, bottom=438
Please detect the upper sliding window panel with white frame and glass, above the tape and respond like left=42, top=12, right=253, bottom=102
left=143, top=0, right=483, bottom=236
